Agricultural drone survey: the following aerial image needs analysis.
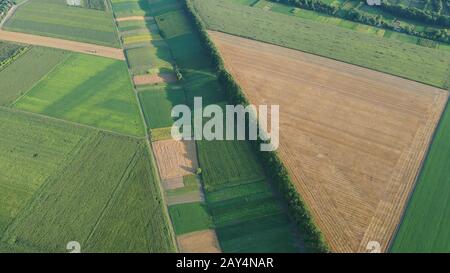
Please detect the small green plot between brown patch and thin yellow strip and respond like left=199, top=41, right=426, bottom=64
left=139, top=85, right=186, bottom=129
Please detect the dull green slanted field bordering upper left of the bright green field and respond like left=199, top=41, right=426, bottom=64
left=0, top=47, right=70, bottom=105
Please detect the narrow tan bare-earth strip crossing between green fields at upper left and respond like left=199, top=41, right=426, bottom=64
left=0, top=30, right=125, bottom=60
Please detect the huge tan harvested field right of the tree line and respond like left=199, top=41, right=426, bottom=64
left=210, top=32, right=447, bottom=252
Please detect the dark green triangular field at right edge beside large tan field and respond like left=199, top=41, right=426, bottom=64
left=391, top=102, right=450, bottom=253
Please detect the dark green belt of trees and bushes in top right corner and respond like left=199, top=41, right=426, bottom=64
left=271, top=0, right=450, bottom=43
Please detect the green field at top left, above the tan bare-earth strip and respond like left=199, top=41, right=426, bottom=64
left=5, top=0, right=119, bottom=47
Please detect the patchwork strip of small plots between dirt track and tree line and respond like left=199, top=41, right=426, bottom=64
left=108, top=0, right=303, bottom=252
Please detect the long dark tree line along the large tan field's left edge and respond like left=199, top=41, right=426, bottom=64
left=184, top=0, right=329, bottom=252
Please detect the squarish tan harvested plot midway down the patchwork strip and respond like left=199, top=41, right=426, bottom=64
left=153, top=140, right=198, bottom=180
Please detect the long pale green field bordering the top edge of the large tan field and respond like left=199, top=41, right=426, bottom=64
left=192, top=0, right=450, bottom=87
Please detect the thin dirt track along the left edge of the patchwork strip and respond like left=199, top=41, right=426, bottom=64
left=106, top=0, right=180, bottom=253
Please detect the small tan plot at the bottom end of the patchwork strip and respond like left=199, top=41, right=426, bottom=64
left=177, top=229, right=221, bottom=253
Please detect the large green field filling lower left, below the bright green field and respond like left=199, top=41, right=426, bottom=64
left=0, top=109, right=175, bottom=252
